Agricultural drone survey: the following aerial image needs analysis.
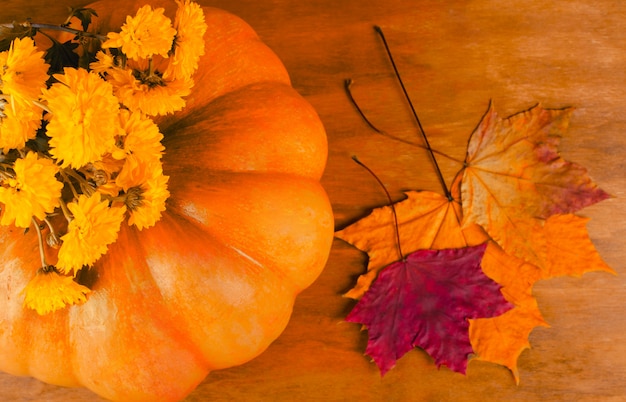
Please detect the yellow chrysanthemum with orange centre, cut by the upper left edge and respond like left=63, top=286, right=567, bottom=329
left=0, top=38, right=49, bottom=107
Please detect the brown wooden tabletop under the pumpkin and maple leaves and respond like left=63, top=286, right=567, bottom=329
left=0, top=0, right=626, bottom=402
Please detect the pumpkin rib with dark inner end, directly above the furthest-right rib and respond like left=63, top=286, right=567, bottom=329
left=163, top=82, right=328, bottom=180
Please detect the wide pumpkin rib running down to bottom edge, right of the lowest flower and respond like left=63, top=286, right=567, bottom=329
left=65, top=223, right=209, bottom=400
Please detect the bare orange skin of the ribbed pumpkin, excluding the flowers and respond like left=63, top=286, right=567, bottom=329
left=0, top=0, right=333, bottom=401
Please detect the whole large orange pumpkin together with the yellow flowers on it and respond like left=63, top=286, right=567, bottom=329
left=0, top=0, right=333, bottom=401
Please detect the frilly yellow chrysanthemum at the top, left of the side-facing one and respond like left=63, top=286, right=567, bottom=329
left=102, top=5, right=176, bottom=60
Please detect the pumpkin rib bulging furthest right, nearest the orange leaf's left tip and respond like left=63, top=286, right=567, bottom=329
left=168, top=172, right=333, bottom=290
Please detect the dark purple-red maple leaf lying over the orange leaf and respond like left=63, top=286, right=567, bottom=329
left=346, top=244, right=512, bottom=375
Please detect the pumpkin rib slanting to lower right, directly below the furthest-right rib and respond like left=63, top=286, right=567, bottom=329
left=135, top=213, right=295, bottom=369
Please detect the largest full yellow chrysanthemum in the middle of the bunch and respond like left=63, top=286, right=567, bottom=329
left=44, top=68, right=120, bottom=168
